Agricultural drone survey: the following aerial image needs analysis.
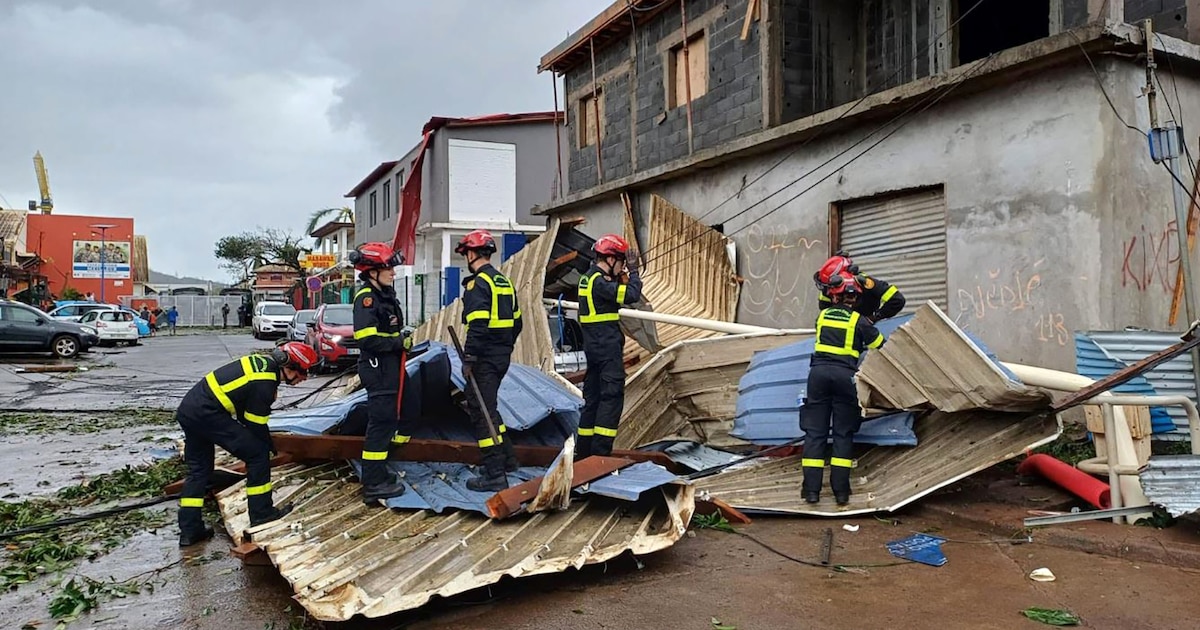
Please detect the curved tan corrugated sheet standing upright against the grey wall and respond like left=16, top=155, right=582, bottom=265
left=625, top=194, right=740, bottom=362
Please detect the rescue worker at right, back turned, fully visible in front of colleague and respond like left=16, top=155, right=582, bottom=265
left=800, top=271, right=883, bottom=505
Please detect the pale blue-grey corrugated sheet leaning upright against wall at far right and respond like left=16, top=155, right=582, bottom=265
left=1082, top=330, right=1196, bottom=439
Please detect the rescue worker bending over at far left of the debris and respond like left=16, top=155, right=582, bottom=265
left=175, top=342, right=318, bottom=547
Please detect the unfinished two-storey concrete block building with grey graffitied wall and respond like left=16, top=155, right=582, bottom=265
left=540, top=0, right=1200, bottom=370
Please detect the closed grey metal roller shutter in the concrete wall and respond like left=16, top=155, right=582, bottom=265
left=838, top=186, right=947, bottom=313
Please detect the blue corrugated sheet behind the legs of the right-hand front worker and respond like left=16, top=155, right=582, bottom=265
left=730, top=316, right=917, bottom=446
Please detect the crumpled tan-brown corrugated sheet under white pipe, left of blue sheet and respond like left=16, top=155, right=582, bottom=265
left=616, top=334, right=804, bottom=449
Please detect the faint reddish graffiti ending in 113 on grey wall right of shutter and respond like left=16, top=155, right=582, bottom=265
left=954, top=258, right=1070, bottom=346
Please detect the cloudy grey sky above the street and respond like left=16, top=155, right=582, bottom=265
left=0, top=0, right=611, bottom=280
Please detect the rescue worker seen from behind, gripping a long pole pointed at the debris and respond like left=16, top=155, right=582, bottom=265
left=454, top=229, right=522, bottom=491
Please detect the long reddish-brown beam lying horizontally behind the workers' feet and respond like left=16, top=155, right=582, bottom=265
left=271, top=433, right=679, bottom=472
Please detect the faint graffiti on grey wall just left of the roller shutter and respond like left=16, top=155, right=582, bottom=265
left=742, top=223, right=823, bottom=328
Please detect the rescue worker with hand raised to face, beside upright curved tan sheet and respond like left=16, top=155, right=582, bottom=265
left=575, top=234, right=642, bottom=460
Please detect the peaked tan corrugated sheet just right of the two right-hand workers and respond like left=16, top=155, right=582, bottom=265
left=856, top=301, right=1050, bottom=413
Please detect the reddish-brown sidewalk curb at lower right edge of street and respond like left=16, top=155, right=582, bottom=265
left=919, top=503, right=1200, bottom=570
